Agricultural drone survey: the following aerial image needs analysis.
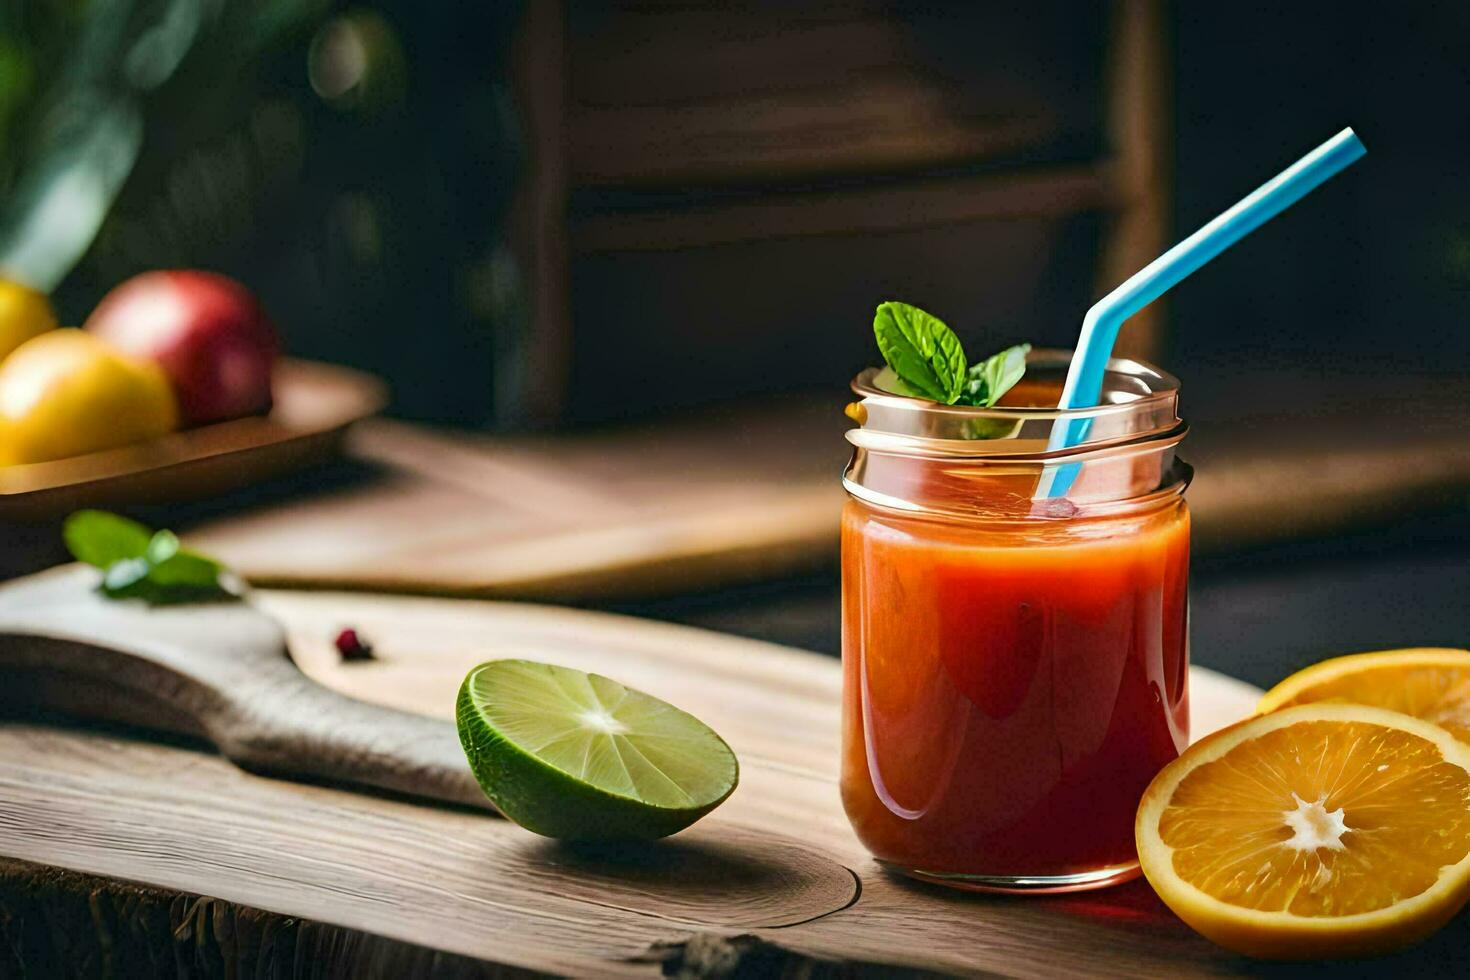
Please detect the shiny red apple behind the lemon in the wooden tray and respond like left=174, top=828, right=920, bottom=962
left=84, top=269, right=279, bottom=425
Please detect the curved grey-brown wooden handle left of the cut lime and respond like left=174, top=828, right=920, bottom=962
left=0, top=566, right=491, bottom=808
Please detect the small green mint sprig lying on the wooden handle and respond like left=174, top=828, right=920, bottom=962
left=62, top=510, right=237, bottom=605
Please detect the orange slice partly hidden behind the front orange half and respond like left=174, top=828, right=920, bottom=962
left=1260, top=649, right=1470, bottom=743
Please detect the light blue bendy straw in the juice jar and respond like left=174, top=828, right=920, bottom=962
left=1035, top=128, right=1367, bottom=498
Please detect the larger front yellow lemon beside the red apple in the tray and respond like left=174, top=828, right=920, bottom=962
left=0, top=329, right=178, bottom=464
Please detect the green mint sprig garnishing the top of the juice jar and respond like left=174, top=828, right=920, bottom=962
left=873, top=301, right=1030, bottom=408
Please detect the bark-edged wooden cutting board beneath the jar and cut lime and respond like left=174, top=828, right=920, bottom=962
left=0, top=578, right=1466, bottom=977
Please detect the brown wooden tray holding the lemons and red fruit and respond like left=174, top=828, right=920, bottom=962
left=0, top=359, right=387, bottom=520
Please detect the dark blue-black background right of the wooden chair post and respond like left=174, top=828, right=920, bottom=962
left=1169, top=3, right=1470, bottom=384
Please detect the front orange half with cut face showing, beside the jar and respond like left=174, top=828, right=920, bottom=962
left=1135, top=702, right=1470, bottom=959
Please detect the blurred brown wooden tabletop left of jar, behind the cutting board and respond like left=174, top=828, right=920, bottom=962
left=190, top=403, right=847, bottom=598
